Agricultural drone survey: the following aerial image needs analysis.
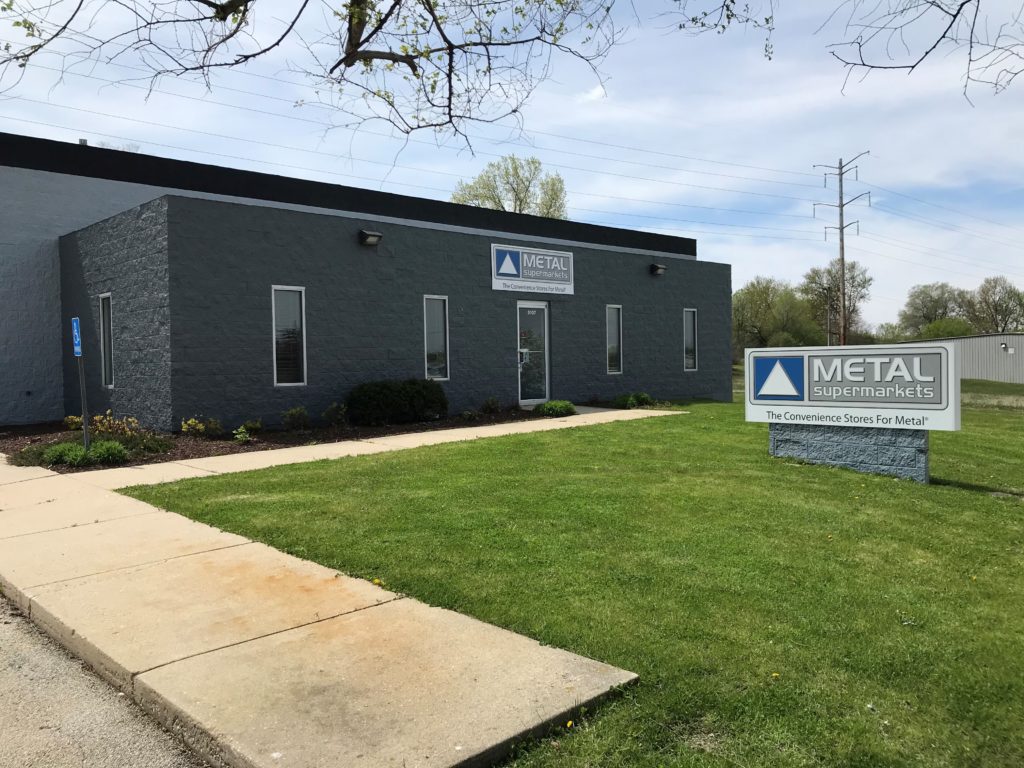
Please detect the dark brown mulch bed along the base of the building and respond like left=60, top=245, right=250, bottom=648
left=0, top=410, right=544, bottom=472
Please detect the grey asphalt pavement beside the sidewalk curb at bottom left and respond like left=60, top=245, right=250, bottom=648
left=0, top=597, right=206, bottom=768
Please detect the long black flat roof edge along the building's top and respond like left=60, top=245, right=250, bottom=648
left=0, top=132, right=696, bottom=257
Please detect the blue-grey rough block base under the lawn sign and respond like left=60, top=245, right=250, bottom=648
left=768, top=423, right=928, bottom=482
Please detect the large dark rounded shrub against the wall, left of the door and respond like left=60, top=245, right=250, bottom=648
left=346, top=379, right=449, bottom=426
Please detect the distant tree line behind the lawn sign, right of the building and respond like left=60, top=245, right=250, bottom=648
left=732, top=266, right=1024, bottom=359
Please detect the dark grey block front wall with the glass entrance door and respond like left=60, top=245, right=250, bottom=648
left=168, top=197, right=731, bottom=424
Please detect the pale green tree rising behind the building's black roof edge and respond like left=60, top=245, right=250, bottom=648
left=452, top=155, right=566, bottom=219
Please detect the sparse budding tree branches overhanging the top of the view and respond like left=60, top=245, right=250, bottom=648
left=0, top=0, right=1024, bottom=136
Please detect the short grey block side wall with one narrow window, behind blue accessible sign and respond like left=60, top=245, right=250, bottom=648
left=60, top=198, right=173, bottom=429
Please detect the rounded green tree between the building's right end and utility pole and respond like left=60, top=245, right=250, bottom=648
left=732, top=278, right=824, bottom=359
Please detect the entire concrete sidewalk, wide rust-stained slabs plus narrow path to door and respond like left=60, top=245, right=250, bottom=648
left=0, top=412, right=655, bottom=768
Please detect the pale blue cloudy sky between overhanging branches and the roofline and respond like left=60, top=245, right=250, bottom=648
left=0, top=3, right=1024, bottom=325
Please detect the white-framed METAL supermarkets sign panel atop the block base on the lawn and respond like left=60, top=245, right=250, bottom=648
left=745, top=344, right=959, bottom=430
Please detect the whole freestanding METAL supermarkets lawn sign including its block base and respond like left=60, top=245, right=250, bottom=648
left=744, top=343, right=961, bottom=482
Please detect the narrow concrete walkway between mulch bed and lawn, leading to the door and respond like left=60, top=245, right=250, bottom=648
left=74, top=407, right=685, bottom=489
